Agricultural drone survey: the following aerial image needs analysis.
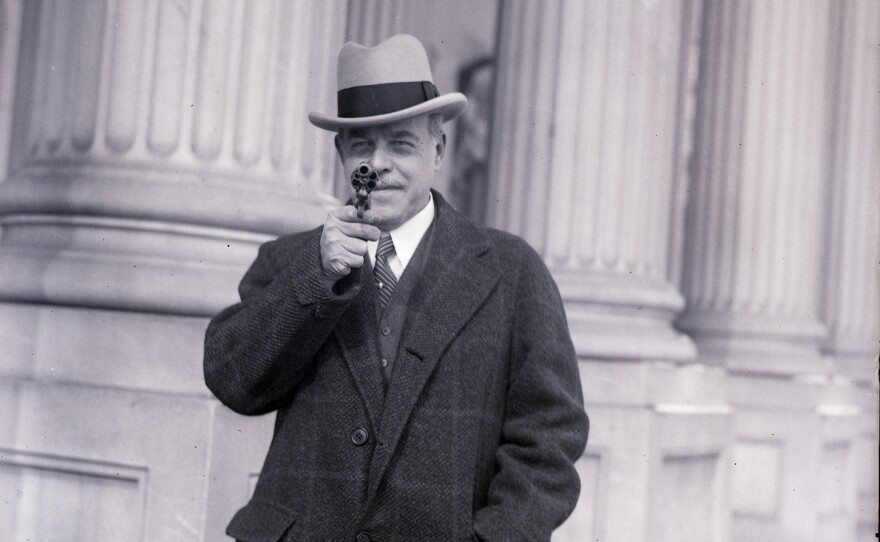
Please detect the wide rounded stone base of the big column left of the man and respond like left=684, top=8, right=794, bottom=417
left=0, top=170, right=329, bottom=316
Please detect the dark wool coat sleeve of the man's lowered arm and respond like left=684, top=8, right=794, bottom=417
left=473, top=243, right=589, bottom=542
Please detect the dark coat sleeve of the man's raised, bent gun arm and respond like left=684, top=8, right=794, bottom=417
left=204, top=230, right=359, bottom=415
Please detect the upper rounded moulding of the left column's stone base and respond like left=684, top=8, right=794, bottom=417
left=0, top=169, right=335, bottom=236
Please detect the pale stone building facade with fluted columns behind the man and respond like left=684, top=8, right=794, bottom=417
left=0, top=0, right=880, bottom=542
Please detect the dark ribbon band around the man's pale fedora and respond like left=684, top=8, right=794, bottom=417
left=336, top=81, right=440, bottom=118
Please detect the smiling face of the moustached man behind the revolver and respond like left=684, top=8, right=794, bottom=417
left=336, top=115, right=446, bottom=231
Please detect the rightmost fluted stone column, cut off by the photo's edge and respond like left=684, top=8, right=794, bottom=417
left=824, top=0, right=880, bottom=540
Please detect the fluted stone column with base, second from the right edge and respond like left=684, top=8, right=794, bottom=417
left=680, top=2, right=829, bottom=373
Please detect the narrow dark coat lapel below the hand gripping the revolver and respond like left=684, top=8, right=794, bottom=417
left=334, top=260, right=385, bottom=431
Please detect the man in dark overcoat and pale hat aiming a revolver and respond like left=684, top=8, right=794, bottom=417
left=205, top=35, right=587, bottom=542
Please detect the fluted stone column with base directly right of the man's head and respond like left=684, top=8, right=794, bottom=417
left=487, top=2, right=694, bottom=361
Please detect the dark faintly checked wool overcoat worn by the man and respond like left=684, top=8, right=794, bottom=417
left=204, top=193, right=588, bottom=542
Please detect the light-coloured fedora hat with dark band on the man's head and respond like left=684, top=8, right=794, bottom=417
left=309, top=34, right=467, bottom=132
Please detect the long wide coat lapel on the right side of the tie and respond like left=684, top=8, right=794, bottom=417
left=367, top=192, right=500, bottom=502
